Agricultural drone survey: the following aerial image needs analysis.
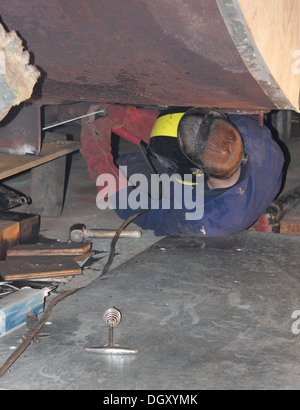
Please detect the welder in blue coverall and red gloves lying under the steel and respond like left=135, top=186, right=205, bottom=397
left=82, top=106, right=284, bottom=237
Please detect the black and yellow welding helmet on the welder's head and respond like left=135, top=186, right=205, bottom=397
left=149, top=107, right=247, bottom=179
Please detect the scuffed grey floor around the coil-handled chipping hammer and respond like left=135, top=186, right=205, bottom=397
left=0, top=119, right=300, bottom=391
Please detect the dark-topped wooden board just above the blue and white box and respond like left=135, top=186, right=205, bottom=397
left=0, top=256, right=82, bottom=281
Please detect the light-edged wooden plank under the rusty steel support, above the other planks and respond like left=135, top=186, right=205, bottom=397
left=0, top=138, right=81, bottom=179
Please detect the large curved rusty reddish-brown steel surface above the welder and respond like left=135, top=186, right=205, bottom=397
left=1, top=0, right=275, bottom=109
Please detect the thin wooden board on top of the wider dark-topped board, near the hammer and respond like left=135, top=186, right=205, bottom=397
left=6, top=243, right=92, bottom=257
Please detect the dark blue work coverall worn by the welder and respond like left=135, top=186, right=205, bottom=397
left=109, top=115, right=284, bottom=237
